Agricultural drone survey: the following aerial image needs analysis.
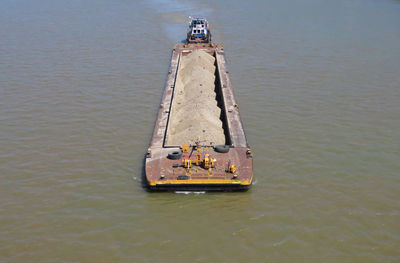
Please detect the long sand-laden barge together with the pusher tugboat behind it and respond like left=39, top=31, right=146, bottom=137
left=145, top=19, right=253, bottom=191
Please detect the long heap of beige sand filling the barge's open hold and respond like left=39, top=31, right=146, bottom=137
left=167, top=50, right=225, bottom=145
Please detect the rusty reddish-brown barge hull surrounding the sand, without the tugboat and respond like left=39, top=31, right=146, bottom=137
left=145, top=43, right=253, bottom=191
